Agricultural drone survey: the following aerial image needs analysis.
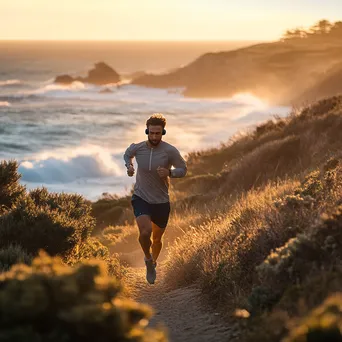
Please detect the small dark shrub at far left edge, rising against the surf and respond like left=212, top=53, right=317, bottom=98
left=0, top=161, right=26, bottom=214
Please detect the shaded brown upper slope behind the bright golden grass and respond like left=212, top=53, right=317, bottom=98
left=173, top=97, right=342, bottom=198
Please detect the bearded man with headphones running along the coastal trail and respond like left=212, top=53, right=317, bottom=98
left=124, top=114, right=187, bottom=284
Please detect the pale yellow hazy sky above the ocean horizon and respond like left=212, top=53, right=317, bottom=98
left=0, top=0, right=342, bottom=40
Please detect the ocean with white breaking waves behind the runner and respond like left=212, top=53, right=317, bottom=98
left=0, top=41, right=290, bottom=201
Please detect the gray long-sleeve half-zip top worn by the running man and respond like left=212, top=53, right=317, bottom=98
left=124, top=141, right=187, bottom=203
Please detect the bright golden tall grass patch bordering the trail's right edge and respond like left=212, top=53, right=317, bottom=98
left=163, top=182, right=297, bottom=301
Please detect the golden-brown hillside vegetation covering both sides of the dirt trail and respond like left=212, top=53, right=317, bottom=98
left=0, top=96, right=342, bottom=342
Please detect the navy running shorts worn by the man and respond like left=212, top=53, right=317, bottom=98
left=131, top=194, right=170, bottom=229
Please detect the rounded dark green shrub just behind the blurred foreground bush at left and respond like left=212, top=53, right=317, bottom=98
left=0, top=194, right=95, bottom=256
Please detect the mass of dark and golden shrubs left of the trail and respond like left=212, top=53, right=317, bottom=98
left=0, top=161, right=167, bottom=342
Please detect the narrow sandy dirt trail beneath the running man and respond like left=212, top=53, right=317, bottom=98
left=123, top=252, right=236, bottom=342
